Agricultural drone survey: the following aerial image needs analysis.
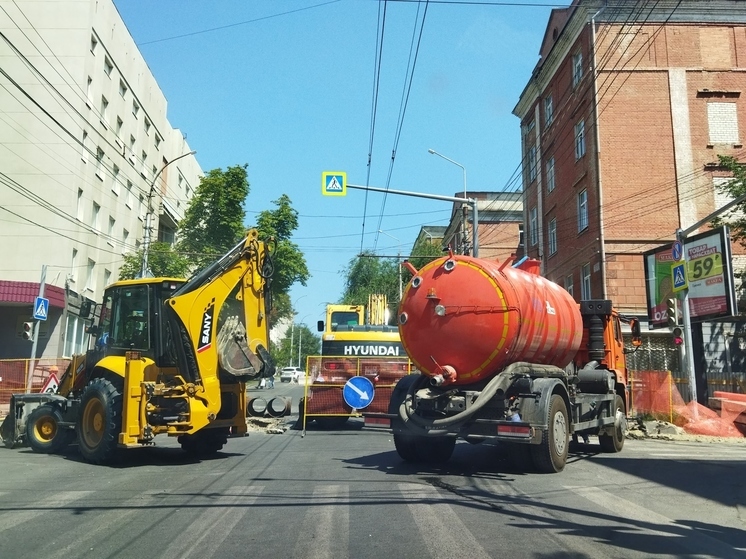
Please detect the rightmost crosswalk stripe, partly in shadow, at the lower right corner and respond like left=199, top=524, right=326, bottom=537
left=565, top=486, right=743, bottom=559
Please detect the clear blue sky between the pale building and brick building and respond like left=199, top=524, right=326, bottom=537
left=114, top=0, right=569, bottom=331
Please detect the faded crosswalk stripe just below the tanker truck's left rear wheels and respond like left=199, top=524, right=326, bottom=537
left=399, top=483, right=491, bottom=559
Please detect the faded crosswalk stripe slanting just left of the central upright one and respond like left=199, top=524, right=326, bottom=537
left=161, top=485, right=264, bottom=559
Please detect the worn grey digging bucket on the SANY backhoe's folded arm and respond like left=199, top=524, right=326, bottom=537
left=217, top=316, right=275, bottom=380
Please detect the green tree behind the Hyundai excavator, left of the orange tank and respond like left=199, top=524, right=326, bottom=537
left=341, top=251, right=404, bottom=314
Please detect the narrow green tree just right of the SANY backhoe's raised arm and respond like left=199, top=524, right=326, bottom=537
left=256, top=194, right=310, bottom=327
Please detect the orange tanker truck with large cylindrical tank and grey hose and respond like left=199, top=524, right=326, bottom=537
left=387, top=253, right=640, bottom=472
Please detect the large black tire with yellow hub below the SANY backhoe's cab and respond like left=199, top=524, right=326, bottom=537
left=77, top=378, right=122, bottom=464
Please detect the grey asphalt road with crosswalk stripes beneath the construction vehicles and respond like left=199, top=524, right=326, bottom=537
left=0, top=383, right=746, bottom=559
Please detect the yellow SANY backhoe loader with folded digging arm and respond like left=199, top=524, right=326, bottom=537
left=2, top=229, right=275, bottom=464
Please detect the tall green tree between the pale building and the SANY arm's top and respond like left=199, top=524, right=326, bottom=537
left=177, top=165, right=249, bottom=269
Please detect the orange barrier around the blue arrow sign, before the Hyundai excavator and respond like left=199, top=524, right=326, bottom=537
left=300, top=355, right=412, bottom=435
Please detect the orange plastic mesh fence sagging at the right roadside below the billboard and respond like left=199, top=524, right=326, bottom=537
left=630, top=371, right=744, bottom=437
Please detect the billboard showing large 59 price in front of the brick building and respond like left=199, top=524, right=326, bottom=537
left=643, top=227, right=737, bottom=328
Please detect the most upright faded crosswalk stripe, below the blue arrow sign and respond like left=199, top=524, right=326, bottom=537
left=292, top=485, right=350, bottom=559
